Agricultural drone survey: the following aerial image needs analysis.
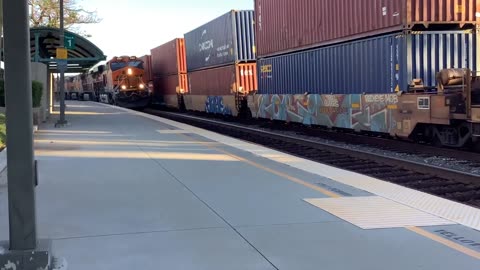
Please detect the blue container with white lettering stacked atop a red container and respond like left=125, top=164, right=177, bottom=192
left=184, top=10, right=255, bottom=71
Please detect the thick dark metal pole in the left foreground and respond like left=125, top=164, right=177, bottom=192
left=3, top=0, right=37, bottom=250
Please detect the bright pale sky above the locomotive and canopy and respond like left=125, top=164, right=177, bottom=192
left=77, top=0, right=254, bottom=61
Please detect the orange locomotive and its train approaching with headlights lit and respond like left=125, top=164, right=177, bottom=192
left=66, top=56, right=152, bottom=109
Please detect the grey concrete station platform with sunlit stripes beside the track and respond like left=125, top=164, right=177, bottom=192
left=0, top=101, right=480, bottom=270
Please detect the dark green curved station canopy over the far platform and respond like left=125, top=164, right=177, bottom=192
left=30, top=27, right=106, bottom=73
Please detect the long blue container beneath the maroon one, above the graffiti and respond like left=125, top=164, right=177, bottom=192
left=257, top=31, right=479, bottom=94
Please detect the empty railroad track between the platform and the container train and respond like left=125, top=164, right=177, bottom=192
left=146, top=110, right=480, bottom=208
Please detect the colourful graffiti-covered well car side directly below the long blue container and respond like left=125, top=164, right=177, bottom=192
left=253, top=94, right=398, bottom=132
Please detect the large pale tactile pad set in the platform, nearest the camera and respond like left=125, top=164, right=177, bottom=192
left=305, top=196, right=455, bottom=229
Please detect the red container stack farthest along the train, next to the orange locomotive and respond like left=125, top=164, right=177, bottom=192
left=150, top=38, right=188, bottom=107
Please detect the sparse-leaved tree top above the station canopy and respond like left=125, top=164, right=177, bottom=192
left=28, top=0, right=100, bottom=34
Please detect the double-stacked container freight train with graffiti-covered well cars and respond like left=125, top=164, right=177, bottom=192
left=144, top=0, right=480, bottom=148
